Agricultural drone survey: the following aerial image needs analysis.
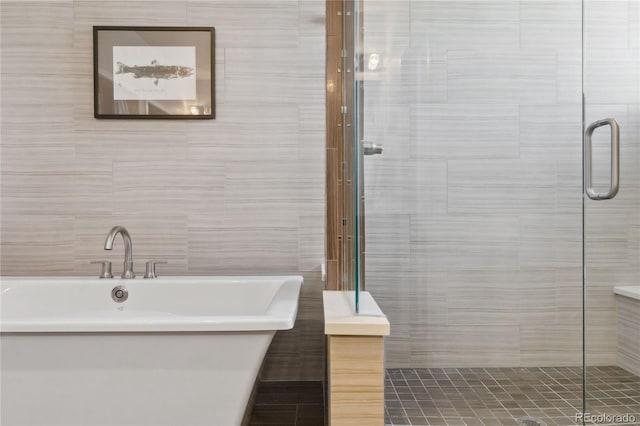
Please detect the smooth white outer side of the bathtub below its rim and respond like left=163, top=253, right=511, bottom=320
left=0, top=331, right=274, bottom=426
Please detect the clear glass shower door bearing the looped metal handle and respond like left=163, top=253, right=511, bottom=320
left=582, top=0, right=640, bottom=424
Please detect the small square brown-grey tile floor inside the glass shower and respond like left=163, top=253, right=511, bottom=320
left=385, top=367, right=640, bottom=426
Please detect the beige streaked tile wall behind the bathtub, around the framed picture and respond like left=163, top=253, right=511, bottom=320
left=1, top=0, right=325, bottom=380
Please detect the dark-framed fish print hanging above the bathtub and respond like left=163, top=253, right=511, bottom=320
left=93, top=27, right=215, bottom=119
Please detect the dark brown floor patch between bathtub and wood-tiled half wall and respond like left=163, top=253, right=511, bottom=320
left=249, top=382, right=324, bottom=426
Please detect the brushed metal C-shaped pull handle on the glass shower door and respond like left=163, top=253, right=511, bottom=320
left=583, top=118, right=620, bottom=201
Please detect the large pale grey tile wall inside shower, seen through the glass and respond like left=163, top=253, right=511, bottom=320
left=363, top=0, right=640, bottom=368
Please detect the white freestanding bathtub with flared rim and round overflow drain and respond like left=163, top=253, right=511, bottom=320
left=0, top=276, right=302, bottom=426
